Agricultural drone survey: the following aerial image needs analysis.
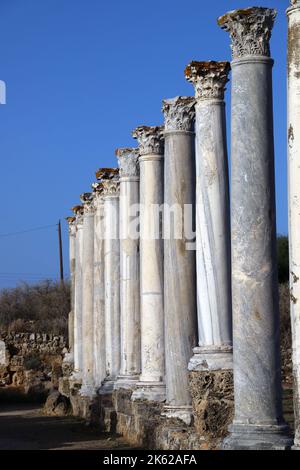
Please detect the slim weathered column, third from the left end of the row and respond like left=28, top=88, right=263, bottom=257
left=80, top=193, right=95, bottom=398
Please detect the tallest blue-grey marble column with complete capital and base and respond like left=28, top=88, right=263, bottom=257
left=218, top=7, right=290, bottom=449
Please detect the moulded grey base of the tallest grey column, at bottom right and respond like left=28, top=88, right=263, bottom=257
left=222, top=424, right=293, bottom=450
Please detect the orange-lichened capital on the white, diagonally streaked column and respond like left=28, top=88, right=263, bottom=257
left=184, top=61, right=230, bottom=100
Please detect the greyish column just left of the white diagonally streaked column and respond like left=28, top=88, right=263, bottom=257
left=163, top=96, right=197, bottom=424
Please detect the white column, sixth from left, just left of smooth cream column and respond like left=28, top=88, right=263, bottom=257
left=116, top=148, right=141, bottom=388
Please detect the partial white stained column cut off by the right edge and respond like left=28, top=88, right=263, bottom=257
left=287, top=0, right=300, bottom=450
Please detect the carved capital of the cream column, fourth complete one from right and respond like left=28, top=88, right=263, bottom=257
left=132, top=126, right=164, bottom=155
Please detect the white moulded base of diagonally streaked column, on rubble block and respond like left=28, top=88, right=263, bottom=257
left=188, top=346, right=233, bottom=371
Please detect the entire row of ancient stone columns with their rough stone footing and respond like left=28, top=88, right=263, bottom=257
left=59, top=0, right=300, bottom=450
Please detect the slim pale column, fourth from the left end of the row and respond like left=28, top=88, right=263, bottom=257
left=92, top=182, right=106, bottom=390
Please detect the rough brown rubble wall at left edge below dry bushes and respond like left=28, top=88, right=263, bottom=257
left=0, top=333, right=67, bottom=397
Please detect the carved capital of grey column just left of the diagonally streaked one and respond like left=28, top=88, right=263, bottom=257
left=162, top=96, right=196, bottom=132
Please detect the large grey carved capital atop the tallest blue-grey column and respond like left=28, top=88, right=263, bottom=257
left=218, top=7, right=276, bottom=59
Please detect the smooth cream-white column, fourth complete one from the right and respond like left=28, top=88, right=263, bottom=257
left=132, top=126, right=165, bottom=401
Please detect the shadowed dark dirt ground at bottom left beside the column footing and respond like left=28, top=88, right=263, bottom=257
left=0, top=403, right=132, bottom=450
